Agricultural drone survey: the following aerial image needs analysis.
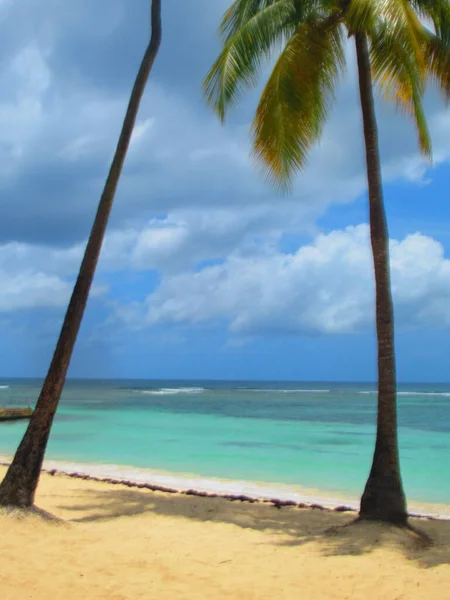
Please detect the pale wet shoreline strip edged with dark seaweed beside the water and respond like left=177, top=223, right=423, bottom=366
left=0, top=456, right=450, bottom=521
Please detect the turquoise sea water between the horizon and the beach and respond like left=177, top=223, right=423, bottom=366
left=0, top=380, right=450, bottom=504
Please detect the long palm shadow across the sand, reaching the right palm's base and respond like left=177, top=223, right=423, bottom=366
left=55, top=488, right=450, bottom=568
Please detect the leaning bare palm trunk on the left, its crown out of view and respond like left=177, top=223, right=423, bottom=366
left=0, top=0, right=161, bottom=508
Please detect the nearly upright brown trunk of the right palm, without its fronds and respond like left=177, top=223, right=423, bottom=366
left=355, top=33, right=407, bottom=524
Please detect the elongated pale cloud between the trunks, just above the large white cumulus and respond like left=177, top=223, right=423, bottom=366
left=100, top=203, right=315, bottom=273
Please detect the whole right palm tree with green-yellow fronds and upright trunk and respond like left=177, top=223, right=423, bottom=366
left=204, top=0, right=450, bottom=524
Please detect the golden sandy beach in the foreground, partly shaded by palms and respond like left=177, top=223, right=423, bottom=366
left=0, top=467, right=450, bottom=600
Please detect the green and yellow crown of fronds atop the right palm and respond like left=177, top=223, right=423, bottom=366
left=204, top=0, right=450, bottom=185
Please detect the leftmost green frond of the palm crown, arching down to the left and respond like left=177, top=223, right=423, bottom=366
left=203, top=0, right=295, bottom=121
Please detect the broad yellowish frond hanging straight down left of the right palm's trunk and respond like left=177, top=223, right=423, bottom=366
left=252, top=14, right=345, bottom=188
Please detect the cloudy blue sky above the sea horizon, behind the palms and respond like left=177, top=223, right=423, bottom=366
left=0, top=0, right=450, bottom=382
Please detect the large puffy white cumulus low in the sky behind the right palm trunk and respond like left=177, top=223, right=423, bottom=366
left=136, top=225, right=450, bottom=334
